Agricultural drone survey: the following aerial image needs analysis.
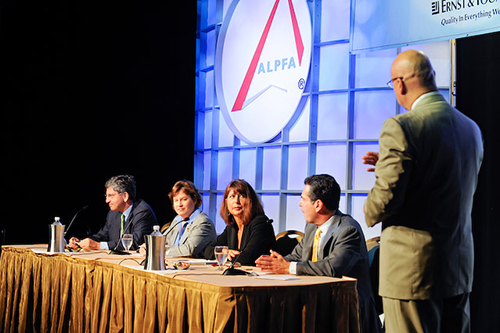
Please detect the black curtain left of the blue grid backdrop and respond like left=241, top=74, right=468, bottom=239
left=0, top=0, right=197, bottom=244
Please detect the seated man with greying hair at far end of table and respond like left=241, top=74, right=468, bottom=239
left=68, top=175, right=157, bottom=250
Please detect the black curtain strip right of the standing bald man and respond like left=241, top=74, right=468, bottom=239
left=456, top=33, right=500, bottom=332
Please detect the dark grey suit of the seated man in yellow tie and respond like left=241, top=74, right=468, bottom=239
left=285, top=211, right=381, bottom=333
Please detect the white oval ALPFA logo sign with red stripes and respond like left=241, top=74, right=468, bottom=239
left=215, top=0, right=311, bottom=143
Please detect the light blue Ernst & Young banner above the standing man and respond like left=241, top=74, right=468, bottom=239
left=351, top=0, right=500, bottom=52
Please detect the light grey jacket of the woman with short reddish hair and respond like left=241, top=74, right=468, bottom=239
left=163, top=212, right=217, bottom=257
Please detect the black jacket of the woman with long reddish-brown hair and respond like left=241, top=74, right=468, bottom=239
left=205, top=215, right=276, bottom=266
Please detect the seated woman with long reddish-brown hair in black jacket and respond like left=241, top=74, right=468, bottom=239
left=205, top=179, right=275, bottom=265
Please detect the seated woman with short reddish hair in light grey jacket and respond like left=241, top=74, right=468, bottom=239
left=139, top=180, right=216, bottom=257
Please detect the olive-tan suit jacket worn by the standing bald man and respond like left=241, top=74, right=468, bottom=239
left=364, top=94, right=483, bottom=299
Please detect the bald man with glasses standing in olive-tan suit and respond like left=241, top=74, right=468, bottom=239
left=363, top=50, right=483, bottom=333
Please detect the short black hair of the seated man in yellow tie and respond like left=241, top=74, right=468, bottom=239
left=304, top=174, right=340, bottom=212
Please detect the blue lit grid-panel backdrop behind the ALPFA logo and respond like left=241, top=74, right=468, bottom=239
left=194, top=0, right=452, bottom=239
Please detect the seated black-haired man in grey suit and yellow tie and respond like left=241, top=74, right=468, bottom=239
left=255, top=175, right=381, bottom=333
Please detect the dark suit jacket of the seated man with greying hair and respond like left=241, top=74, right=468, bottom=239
left=90, top=199, right=157, bottom=250
